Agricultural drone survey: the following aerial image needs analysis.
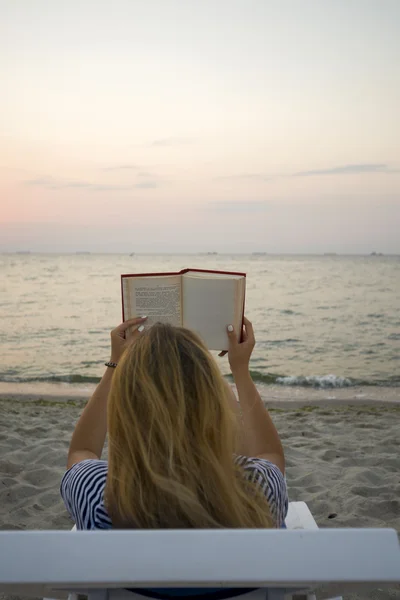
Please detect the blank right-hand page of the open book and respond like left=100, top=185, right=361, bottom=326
left=182, top=273, right=245, bottom=350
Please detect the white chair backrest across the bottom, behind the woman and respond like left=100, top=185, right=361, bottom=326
left=0, top=529, right=400, bottom=597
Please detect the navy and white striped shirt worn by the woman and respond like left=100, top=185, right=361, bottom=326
left=60, top=456, right=288, bottom=529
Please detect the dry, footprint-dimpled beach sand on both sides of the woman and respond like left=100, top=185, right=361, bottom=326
left=0, top=390, right=400, bottom=599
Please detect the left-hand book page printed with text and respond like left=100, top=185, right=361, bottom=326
left=122, top=275, right=182, bottom=328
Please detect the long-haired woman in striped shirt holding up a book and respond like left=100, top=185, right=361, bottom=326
left=61, top=317, right=288, bottom=529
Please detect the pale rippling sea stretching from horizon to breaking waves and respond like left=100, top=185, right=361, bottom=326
left=0, top=253, right=400, bottom=393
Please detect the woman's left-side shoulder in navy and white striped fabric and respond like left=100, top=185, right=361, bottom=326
left=60, top=459, right=111, bottom=529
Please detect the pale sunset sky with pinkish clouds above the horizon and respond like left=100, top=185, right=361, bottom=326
left=0, top=0, right=400, bottom=254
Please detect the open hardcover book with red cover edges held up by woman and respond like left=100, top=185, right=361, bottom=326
left=121, top=269, right=246, bottom=350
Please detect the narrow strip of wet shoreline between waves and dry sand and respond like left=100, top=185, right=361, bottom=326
left=0, top=382, right=400, bottom=408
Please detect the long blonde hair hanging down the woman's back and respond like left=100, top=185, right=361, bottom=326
left=105, top=324, right=275, bottom=529
